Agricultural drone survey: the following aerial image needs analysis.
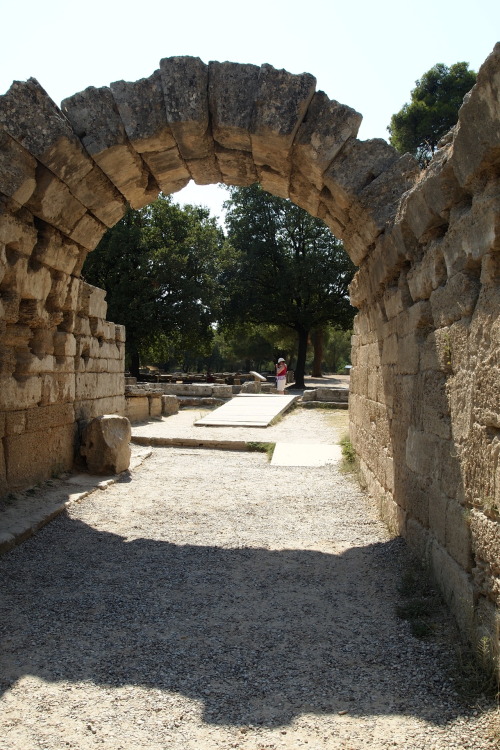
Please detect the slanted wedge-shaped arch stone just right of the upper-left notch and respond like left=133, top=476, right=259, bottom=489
left=61, top=86, right=159, bottom=208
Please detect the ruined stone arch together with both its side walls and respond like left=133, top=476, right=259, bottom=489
left=0, top=45, right=500, bottom=649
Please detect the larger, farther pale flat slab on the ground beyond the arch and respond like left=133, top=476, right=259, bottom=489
left=195, top=393, right=298, bottom=427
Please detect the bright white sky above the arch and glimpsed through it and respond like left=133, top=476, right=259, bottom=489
left=0, top=0, right=500, bottom=223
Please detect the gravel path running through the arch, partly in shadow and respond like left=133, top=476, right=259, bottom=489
left=0, top=411, right=497, bottom=750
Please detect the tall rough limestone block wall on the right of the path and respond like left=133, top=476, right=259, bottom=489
left=350, top=45, right=500, bottom=655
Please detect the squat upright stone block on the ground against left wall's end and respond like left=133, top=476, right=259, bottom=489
left=80, top=414, right=132, bottom=474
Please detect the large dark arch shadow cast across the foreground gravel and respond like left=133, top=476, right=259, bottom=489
left=0, top=516, right=457, bottom=727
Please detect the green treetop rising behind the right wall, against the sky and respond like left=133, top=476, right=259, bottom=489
left=387, top=62, right=476, bottom=166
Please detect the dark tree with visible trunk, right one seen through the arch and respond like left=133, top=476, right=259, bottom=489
left=221, top=185, right=355, bottom=387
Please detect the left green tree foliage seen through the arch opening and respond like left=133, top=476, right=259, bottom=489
left=83, top=196, right=224, bottom=370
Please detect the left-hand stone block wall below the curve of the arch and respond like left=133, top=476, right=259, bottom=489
left=0, top=276, right=125, bottom=494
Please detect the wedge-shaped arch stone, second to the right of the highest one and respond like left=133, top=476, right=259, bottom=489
left=251, top=64, right=316, bottom=174
